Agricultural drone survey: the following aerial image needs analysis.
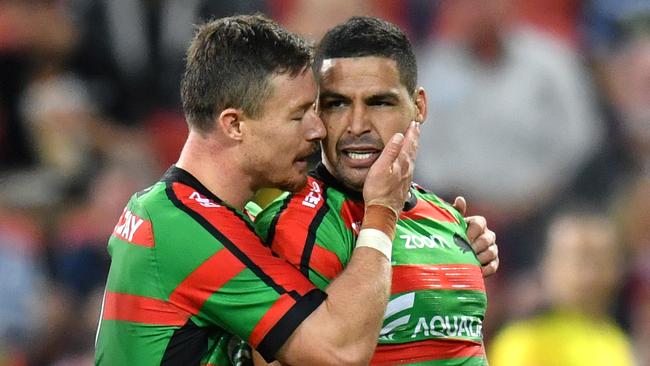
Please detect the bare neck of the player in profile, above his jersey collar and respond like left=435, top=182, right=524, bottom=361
left=176, top=131, right=254, bottom=210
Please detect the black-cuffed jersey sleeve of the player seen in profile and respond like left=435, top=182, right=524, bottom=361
left=168, top=183, right=327, bottom=362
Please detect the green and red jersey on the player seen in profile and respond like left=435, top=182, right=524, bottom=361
left=95, top=167, right=326, bottom=365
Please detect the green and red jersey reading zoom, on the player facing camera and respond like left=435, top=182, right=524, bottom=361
left=255, top=165, right=487, bottom=365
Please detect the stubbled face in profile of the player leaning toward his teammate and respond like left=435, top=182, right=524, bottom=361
left=244, top=69, right=325, bottom=191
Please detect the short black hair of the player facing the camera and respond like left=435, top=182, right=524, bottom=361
left=314, top=17, right=417, bottom=93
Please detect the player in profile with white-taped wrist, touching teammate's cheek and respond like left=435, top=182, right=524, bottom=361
left=95, top=16, right=418, bottom=365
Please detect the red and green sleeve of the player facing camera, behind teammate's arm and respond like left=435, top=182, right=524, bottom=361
left=255, top=181, right=354, bottom=289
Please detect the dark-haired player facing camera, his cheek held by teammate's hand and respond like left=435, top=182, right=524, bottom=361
left=251, top=17, right=498, bottom=365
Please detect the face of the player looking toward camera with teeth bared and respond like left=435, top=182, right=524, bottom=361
left=319, top=56, right=426, bottom=191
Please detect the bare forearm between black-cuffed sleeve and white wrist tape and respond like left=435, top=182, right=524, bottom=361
left=278, top=248, right=391, bottom=365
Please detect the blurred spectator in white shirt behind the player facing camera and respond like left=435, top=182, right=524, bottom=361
left=416, top=0, right=603, bottom=271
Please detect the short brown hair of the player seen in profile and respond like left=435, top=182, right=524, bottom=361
left=181, top=14, right=312, bottom=132
